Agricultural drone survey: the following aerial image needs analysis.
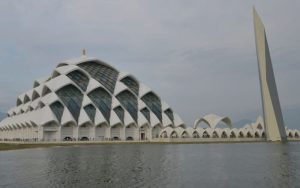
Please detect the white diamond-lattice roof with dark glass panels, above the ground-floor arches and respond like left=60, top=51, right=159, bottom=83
left=0, top=57, right=185, bottom=127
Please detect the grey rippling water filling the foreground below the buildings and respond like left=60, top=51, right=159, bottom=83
left=0, top=142, right=300, bottom=188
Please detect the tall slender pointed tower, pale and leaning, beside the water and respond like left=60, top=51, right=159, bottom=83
left=253, top=8, right=286, bottom=141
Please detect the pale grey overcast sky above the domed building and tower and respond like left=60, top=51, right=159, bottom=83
left=0, top=0, right=300, bottom=128
